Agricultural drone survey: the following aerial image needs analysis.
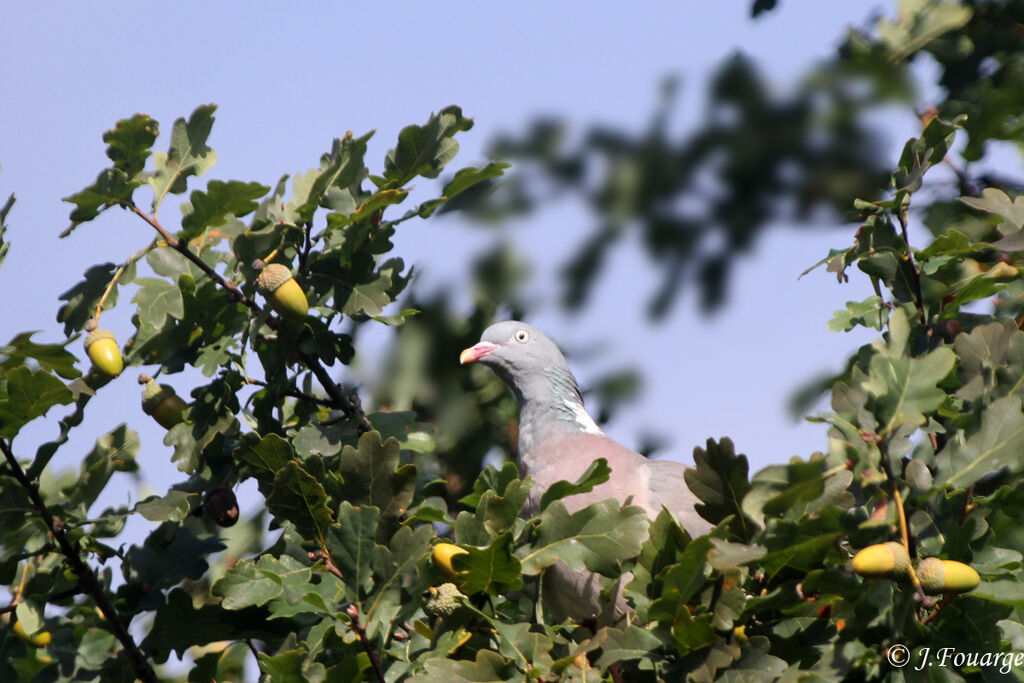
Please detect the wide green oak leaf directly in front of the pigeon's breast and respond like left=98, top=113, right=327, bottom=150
left=520, top=500, right=648, bottom=577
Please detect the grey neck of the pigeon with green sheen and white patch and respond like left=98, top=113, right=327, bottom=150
left=512, top=368, right=601, bottom=473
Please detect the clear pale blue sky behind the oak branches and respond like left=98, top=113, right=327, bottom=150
left=0, top=0, right=901, bottom=528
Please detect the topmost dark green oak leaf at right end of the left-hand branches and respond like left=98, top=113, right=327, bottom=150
left=384, top=106, right=473, bottom=187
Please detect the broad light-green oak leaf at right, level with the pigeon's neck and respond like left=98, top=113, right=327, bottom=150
left=864, top=347, right=956, bottom=433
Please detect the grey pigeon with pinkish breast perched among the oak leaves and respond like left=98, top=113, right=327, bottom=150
left=459, top=321, right=712, bottom=622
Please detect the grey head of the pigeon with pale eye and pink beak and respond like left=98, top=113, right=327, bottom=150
left=459, top=321, right=568, bottom=388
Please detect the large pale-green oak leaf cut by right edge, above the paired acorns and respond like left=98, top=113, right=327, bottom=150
left=935, top=394, right=1024, bottom=487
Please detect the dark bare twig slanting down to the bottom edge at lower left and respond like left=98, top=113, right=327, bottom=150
left=0, top=439, right=159, bottom=683
